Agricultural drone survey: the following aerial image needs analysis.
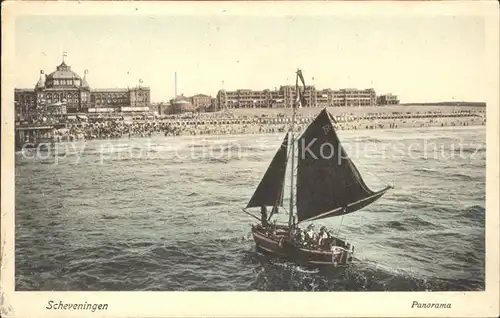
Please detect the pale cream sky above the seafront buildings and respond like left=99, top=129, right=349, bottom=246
left=15, top=14, right=488, bottom=102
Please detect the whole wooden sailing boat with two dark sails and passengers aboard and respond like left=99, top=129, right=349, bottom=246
left=243, top=70, right=392, bottom=266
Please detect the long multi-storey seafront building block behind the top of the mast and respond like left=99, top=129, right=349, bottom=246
left=215, top=85, right=377, bottom=109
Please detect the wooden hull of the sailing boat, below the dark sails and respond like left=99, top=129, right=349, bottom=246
left=252, top=228, right=353, bottom=267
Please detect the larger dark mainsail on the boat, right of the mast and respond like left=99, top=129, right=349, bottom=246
left=297, top=109, right=388, bottom=222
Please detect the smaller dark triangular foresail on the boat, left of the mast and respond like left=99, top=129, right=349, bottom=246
left=247, top=134, right=288, bottom=208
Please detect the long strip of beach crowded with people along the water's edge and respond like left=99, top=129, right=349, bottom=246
left=21, top=108, right=486, bottom=142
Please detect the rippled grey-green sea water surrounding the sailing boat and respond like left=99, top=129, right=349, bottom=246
left=15, top=127, right=486, bottom=291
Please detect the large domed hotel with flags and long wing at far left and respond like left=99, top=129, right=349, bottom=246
left=14, top=60, right=150, bottom=119
